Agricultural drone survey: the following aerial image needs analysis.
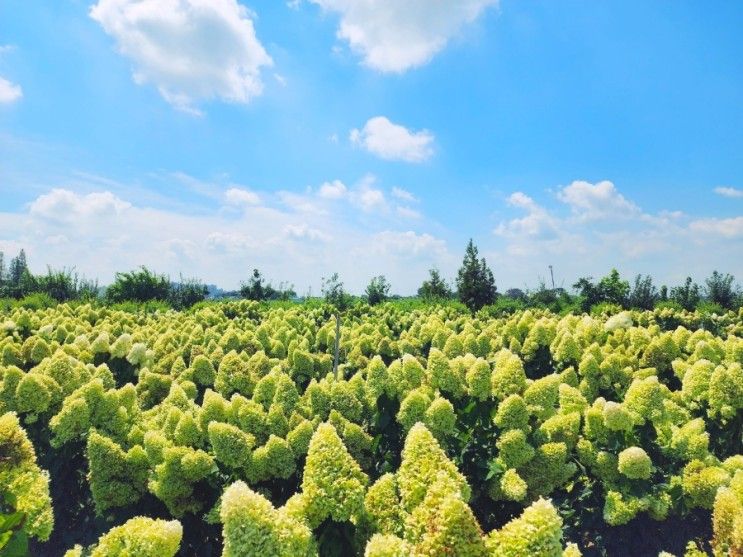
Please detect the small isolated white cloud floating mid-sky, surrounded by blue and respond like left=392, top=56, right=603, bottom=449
left=350, top=116, right=434, bottom=162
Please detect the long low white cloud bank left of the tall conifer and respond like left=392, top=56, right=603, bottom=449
left=0, top=184, right=449, bottom=294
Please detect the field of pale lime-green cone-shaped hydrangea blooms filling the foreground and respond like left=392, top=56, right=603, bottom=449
left=0, top=301, right=743, bottom=557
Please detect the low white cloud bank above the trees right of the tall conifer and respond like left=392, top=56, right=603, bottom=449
left=489, top=181, right=743, bottom=286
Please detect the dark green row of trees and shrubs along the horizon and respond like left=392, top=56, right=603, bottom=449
left=0, top=240, right=743, bottom=313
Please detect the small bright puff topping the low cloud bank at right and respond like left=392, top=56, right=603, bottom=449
left=557, top=180, right=640, bottom=220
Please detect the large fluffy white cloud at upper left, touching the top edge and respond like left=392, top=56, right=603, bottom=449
left=90, top=0, right=272, bottom=112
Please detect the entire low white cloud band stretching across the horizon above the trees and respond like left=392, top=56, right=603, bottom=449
left=0, top=180, right=743, bottom=294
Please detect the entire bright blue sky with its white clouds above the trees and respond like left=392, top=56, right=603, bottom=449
left=0, top=0, right=743, bottom=294
